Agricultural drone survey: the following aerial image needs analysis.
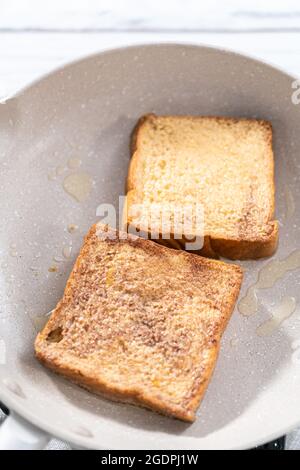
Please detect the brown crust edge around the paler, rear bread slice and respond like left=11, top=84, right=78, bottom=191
left=124, top=114, right=279, bottom=260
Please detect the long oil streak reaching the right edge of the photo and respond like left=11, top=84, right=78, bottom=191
left=238, top=250, right=300, bottom=316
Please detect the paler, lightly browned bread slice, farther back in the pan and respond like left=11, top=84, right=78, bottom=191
left=124, top=114, right=278, bottom=259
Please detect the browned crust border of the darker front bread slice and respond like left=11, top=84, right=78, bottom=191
left=35, top=224, right=242, bottom=422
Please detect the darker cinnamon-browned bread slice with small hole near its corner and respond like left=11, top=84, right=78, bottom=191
left=35, top=225, right=242, bottom=421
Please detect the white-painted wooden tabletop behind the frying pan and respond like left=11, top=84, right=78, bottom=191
left=0, top=0, right=300, bottom=449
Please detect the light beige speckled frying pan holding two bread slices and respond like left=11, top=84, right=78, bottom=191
left=0, top=44, right=300, bottom=449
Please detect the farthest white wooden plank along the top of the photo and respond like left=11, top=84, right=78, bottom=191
left=0, top=0, right=300, bottom=31
